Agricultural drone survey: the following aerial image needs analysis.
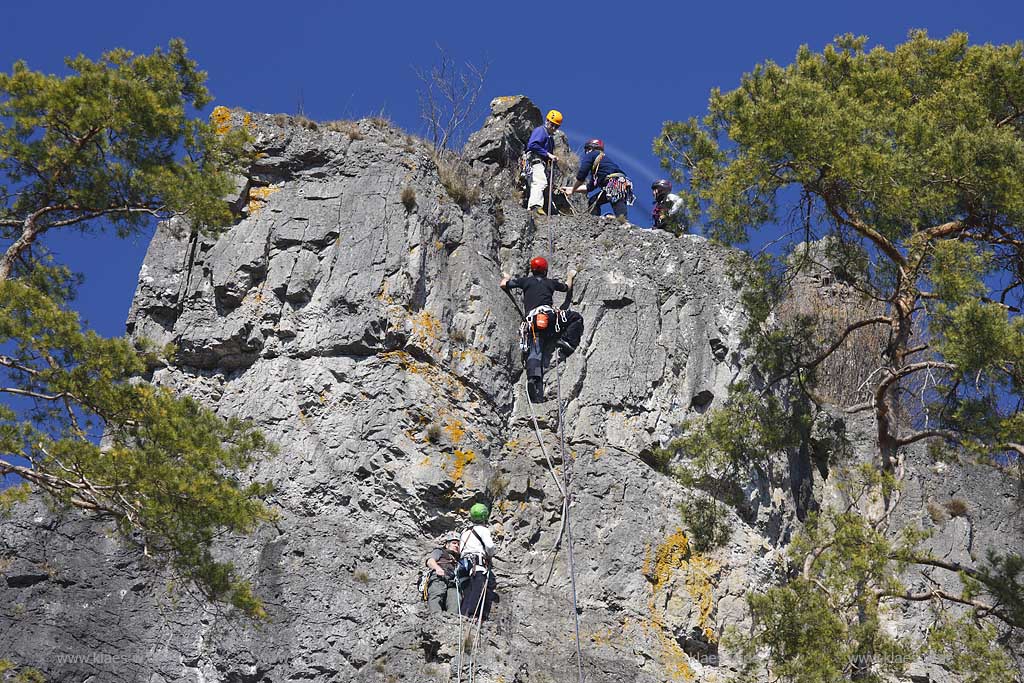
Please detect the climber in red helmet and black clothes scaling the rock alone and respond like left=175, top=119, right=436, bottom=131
left=501, top=256, right=583, bottom=403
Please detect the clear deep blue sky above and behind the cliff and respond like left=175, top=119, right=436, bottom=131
left=0, top=0, right=1024, bottom=335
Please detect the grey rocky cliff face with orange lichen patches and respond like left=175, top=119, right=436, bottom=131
left=0, top=98, right=1021, bottom=683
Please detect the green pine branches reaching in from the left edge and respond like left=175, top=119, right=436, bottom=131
left=0, top=41, right=274, bottom=617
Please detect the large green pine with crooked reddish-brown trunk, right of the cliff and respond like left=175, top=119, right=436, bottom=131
left=654, top=32, right=1024, bottom=683
